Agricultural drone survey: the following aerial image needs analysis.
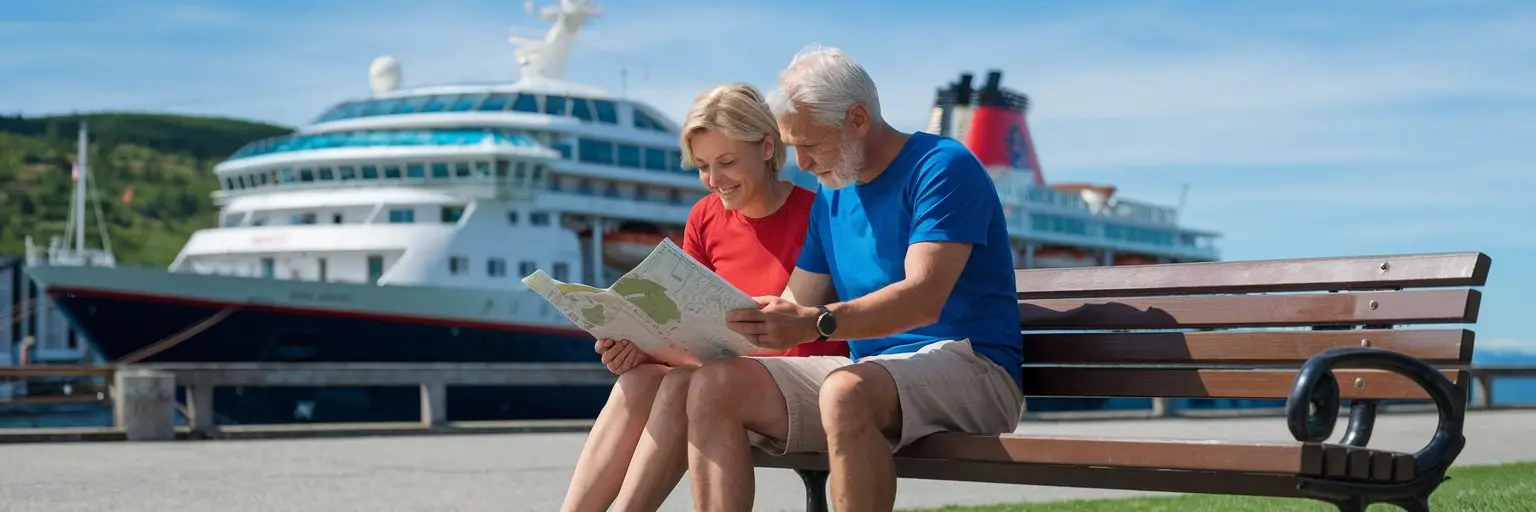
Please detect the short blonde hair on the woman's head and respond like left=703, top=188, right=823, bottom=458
left=677, top=81, right=785, bottom=175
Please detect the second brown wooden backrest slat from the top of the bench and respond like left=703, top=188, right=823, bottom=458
left=1018, top=289, right=1482, bottom=331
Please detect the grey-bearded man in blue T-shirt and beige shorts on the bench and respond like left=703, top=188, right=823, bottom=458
left=688, top=45, right=1023, bottom=510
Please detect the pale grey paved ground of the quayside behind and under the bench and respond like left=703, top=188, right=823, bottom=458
left=0, top=411, right=1536, bottom=512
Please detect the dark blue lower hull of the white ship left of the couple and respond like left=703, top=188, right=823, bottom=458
left=51, top=289, right=610, bottom=424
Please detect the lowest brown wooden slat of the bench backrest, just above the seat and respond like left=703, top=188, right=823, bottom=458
left=1025, top=367, right=1462, bottom=400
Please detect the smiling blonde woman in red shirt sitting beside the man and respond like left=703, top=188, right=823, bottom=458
left=564, top=83, right=848, bottom=512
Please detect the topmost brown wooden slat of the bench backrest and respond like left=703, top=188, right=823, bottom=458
left=1014, top=252, right=1491, bottom=298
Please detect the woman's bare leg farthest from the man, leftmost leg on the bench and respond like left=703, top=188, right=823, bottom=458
left=561, top=364, right=668, bottom=512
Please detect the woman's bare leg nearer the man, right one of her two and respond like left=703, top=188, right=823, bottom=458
left=613, top=367, right=693, bottom=512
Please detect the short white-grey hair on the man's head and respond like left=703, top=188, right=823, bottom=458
left=768, top=43, right=880, bottom=126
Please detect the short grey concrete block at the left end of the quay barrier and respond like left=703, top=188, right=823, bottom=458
left=112, top=369, right=177, bottom=441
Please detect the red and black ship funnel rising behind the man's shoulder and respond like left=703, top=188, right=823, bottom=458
left=931, top=69, right=1044, bottom=185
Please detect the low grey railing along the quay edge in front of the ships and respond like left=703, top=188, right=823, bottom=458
left=0, top=363, right=1536, bottom=440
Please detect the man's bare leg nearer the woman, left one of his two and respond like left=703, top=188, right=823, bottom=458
left=688, top=358, right=790, bottom=512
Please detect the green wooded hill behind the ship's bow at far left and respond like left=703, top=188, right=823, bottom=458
left=0, top=114, right=292, bottom=266
